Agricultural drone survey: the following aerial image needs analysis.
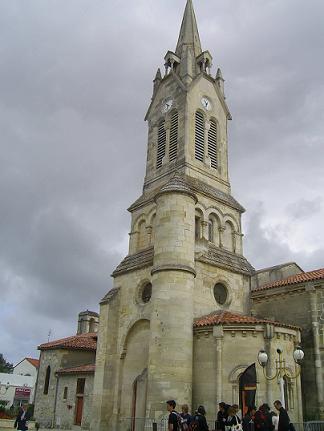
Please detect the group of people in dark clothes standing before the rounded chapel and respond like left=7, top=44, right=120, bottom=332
left=167, top=400, right=295, bottom=431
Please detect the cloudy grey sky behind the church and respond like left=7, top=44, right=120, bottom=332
left=0, top=0, right=324, bottom=363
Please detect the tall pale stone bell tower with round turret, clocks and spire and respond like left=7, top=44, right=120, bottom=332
left=92, top=0, right=252, bottom=431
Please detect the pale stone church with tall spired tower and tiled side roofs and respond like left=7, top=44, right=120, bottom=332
left=36, top=0, right=324, bottom=431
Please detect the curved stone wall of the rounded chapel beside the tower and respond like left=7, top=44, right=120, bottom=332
left=192, top=325, right=302, bottom=422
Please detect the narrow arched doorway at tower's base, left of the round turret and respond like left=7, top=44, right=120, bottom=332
left=131, top=369, right=147, bottom=431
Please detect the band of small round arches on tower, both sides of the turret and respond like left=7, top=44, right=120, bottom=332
left=130, top=206, right=242, bottom=253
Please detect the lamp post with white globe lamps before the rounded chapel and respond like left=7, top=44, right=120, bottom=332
left=258, top=346, right=305, bottom=408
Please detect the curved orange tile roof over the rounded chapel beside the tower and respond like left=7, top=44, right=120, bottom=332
left=194, top=311, right=298, bottom=329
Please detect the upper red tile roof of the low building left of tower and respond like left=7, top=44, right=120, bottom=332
left=38, top=332, right=97, bottom=351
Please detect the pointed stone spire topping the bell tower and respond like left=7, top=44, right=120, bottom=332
left=176, top=0, right=202, bottom=57
